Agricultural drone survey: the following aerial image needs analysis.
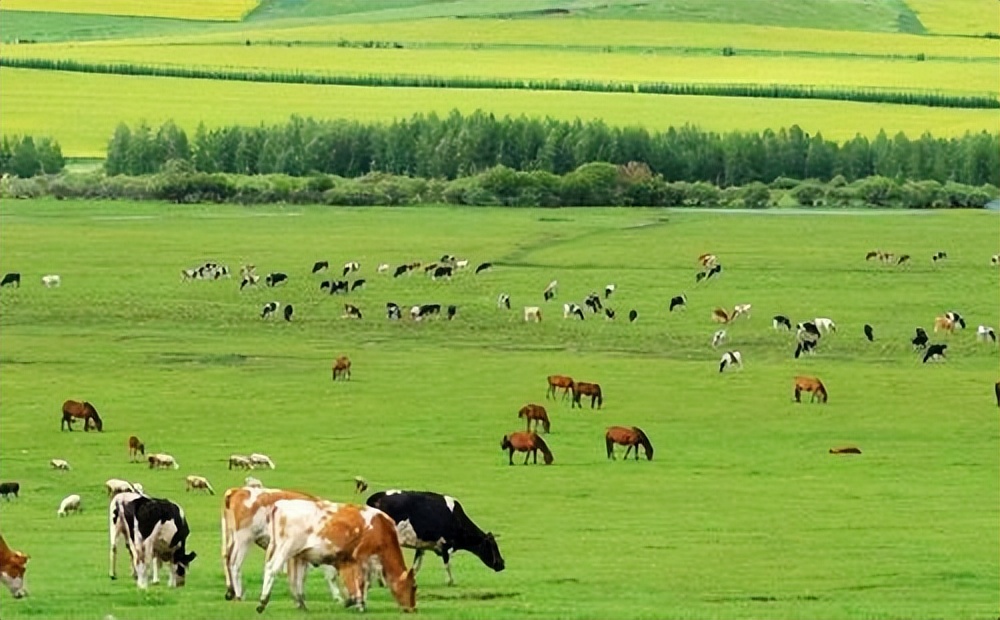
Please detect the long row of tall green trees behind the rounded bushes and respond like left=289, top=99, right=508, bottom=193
left=106, top=111, right=1000, bottom=187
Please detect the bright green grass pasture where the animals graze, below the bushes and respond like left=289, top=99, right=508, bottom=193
left=0, top=201, right=1000, bottom=620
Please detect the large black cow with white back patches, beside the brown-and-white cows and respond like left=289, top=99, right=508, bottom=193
left=366, top=490, right=504, bottom=585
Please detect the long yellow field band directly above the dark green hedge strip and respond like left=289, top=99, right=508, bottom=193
left=0, top=44, right=1000, bottom=95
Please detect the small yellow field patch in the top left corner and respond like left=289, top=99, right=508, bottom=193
left=0, top=0, right=260, bottom=21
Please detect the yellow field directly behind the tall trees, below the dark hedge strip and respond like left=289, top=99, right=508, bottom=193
left=0, top=68, right=997, bottom=157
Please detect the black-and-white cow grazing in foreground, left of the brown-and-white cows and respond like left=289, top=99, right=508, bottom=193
left=108, top=492, right=197, bottom=589
